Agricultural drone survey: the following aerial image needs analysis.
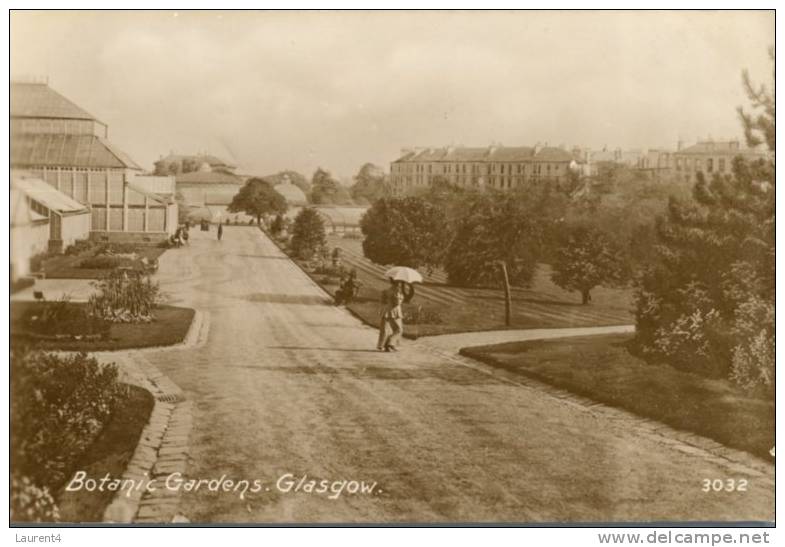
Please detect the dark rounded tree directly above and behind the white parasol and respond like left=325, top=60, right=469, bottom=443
left=360, top=197, right=449, bottom=270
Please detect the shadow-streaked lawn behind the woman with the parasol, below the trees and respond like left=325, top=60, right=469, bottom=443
left=312, top=235, right=633, bottom=338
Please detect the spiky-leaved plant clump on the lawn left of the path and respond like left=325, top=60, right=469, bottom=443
left=88, top=270, right=160, bottom=323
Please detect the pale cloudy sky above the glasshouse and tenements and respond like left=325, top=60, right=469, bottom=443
left=11, top=11, right=774, bottom=177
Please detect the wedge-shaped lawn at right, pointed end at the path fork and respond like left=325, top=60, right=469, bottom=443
left=461, top=334, right=774, bottom=461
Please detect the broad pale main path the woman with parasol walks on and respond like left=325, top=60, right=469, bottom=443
left=136, top=226, right=774, bottom=522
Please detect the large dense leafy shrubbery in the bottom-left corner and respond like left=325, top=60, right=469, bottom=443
left=11, top=348, right=121, bottom=495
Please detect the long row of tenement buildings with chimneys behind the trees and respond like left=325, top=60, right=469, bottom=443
left=390, top=139, right=768, bottom=195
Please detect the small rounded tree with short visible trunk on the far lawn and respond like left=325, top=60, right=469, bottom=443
left=551, top=225, right=626, bottom=304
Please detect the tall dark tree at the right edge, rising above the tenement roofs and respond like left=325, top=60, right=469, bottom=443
left=636, top=50, right=775, bottom=389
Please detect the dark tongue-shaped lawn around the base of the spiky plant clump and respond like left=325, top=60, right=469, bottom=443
left=11, top=302, right=194, bottom=352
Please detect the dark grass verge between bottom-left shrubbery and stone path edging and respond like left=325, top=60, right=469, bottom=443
left=56, top=386, right=154, bottom=522
